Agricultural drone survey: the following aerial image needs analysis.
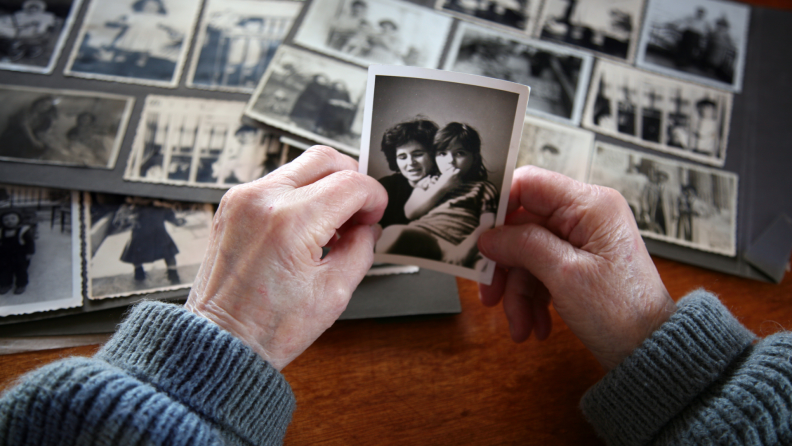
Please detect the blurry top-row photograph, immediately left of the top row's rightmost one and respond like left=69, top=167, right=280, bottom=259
left=537, top=0, right=645, bottom=63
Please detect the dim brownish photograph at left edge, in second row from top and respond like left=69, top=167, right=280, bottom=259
left=0, top=86, right=134, bottom=168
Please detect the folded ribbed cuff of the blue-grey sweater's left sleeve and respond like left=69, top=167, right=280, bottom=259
left=97, top=302, right=295, bottom=444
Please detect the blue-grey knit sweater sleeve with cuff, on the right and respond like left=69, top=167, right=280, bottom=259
left=581, top=290, right=792, bottom=445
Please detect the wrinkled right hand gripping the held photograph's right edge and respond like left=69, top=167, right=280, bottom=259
left=478, top=166, right=676, bottom=370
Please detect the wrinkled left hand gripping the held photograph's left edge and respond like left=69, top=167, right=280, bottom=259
left=186, top=146, right=388, bottom=370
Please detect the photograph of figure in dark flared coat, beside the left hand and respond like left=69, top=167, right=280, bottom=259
left=83, top=193, right=213, bottom=299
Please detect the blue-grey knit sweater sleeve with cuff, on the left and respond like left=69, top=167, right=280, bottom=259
left=0, top=302, right=295, bottom=445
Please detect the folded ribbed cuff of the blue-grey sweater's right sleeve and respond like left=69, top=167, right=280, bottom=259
left=581, top=290, right=754, bottom=445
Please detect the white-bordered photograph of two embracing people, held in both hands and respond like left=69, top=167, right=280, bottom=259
left=360, top=65, right=530, bottom=284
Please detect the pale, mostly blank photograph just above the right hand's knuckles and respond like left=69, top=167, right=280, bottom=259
left=517, top=116, right=594, bottom=182
